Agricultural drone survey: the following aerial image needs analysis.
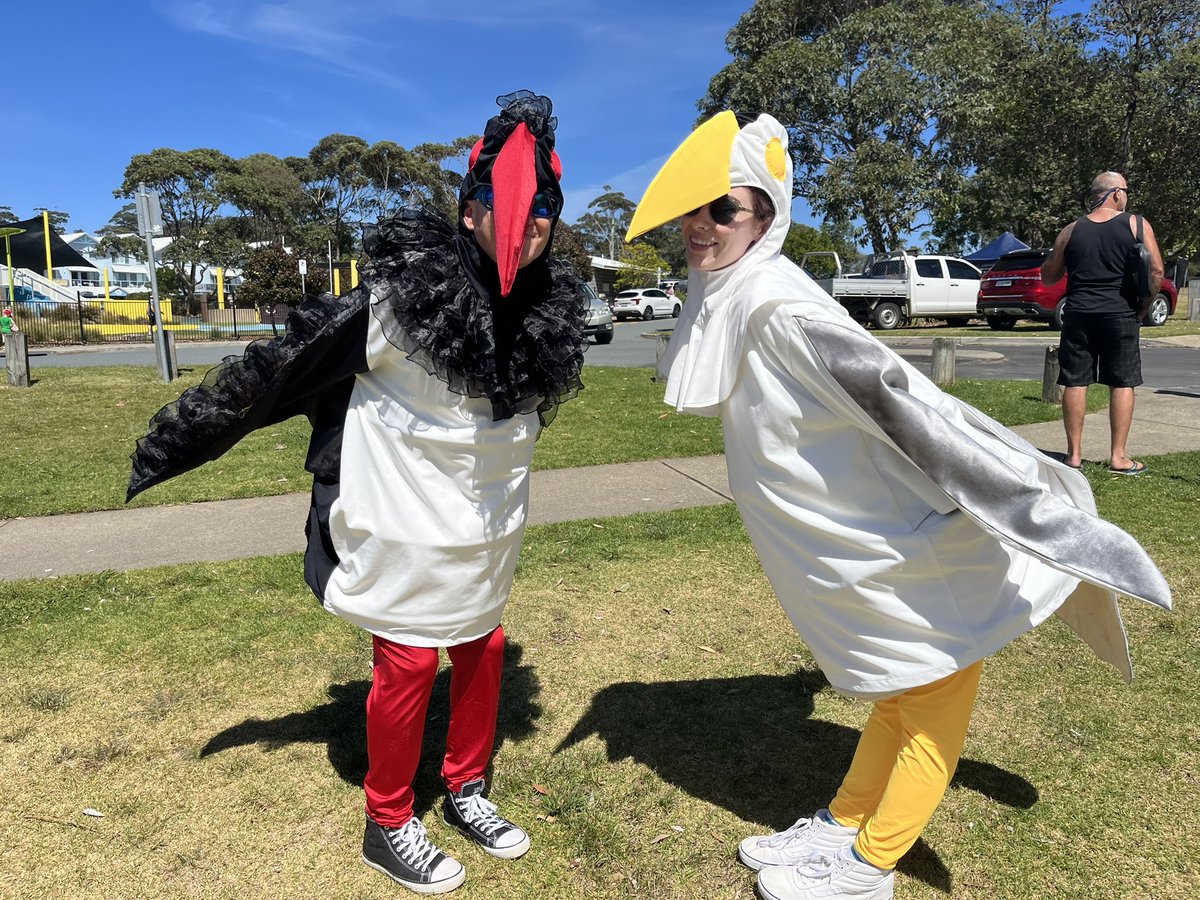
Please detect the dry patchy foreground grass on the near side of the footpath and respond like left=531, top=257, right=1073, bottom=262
left=0, top=455, right=1200, bottom=900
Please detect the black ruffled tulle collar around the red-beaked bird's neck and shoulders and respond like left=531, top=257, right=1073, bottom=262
left=364, top=212, right=588, bottom=425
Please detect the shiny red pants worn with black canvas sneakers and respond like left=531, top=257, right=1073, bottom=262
left=362, top=628, right=504, bottom=828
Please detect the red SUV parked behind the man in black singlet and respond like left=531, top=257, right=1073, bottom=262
left=976, top=248, right=1178, bottom=331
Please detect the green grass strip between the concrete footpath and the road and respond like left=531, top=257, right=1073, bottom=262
left=0, top=366, right=1104, bottom=520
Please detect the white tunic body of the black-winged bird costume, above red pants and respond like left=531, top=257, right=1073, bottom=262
left=324, top=317, right=540, bottom=647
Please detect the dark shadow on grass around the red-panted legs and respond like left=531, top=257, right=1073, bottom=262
left=200, top=640, right=541, bottom=816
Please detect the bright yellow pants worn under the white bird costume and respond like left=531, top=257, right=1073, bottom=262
left=829, top=660, right=983, bottom=869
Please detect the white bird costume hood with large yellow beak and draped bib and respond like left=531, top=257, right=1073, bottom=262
left=625, top=110, right=801, bottom=415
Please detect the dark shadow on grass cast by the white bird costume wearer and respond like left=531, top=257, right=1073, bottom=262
left=554, top=671, right=1038, bottom=893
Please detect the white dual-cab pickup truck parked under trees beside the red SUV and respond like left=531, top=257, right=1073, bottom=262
left=800, top=252, right=982, bottom=329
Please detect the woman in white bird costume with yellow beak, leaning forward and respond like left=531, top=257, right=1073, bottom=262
left=626, top=112, right=1171, bottom=900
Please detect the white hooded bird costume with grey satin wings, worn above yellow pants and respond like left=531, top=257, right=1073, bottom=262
left=630, top=115, right=1170, bottom=698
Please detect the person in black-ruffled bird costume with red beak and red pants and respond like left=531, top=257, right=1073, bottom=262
left=128, top=91, right=588, bottom=894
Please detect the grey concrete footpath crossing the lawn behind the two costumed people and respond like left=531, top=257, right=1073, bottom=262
left=0, top=389, right=1200, bottom=581
